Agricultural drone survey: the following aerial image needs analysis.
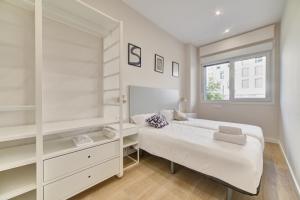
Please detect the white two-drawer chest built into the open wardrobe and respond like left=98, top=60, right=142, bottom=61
left=44, top=140, right=120, bottom=200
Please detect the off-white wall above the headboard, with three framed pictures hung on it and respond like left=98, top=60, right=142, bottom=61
left=85, top=0, right=185, bottom=119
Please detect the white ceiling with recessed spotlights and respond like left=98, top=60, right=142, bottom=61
left=123, top=0, right=285, bottom=46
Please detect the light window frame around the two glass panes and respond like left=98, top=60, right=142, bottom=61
left=201, top=50, right=274, bottom=104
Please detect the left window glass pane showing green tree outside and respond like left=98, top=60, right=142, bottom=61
left=205, top=63, right=229, bottom=101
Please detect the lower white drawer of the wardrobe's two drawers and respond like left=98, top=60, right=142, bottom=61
left=44, top=158, right=120, bottom=200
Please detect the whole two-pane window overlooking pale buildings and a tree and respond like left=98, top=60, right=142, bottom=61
left=203, top=53, right=271, bottom=101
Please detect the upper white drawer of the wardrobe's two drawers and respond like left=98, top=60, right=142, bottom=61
left=44, top=141, right=120, bottom=182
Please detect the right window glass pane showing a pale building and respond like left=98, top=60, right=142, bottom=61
left=234, top=56, right=267, bottom=99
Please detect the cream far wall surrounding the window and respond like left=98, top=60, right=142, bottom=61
left=198, top=26, right=279, bottom=141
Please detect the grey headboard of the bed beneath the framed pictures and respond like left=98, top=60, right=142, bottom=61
left=129, top=86, right=180, bottom=117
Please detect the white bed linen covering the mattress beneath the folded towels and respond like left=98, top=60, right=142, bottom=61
left=139, top=123, right=263, bottom=194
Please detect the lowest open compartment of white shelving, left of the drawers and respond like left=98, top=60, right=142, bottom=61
left=0, top=165, right=36, bottom=199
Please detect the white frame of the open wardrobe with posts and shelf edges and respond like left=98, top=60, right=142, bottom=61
left=0, top=0, right=125, bottom=200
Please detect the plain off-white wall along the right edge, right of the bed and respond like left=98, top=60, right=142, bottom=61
left=280, top=0, right=300, bottom=190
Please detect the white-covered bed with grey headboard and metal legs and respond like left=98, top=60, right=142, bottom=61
left=129, top=86, right=264, bottom=199
